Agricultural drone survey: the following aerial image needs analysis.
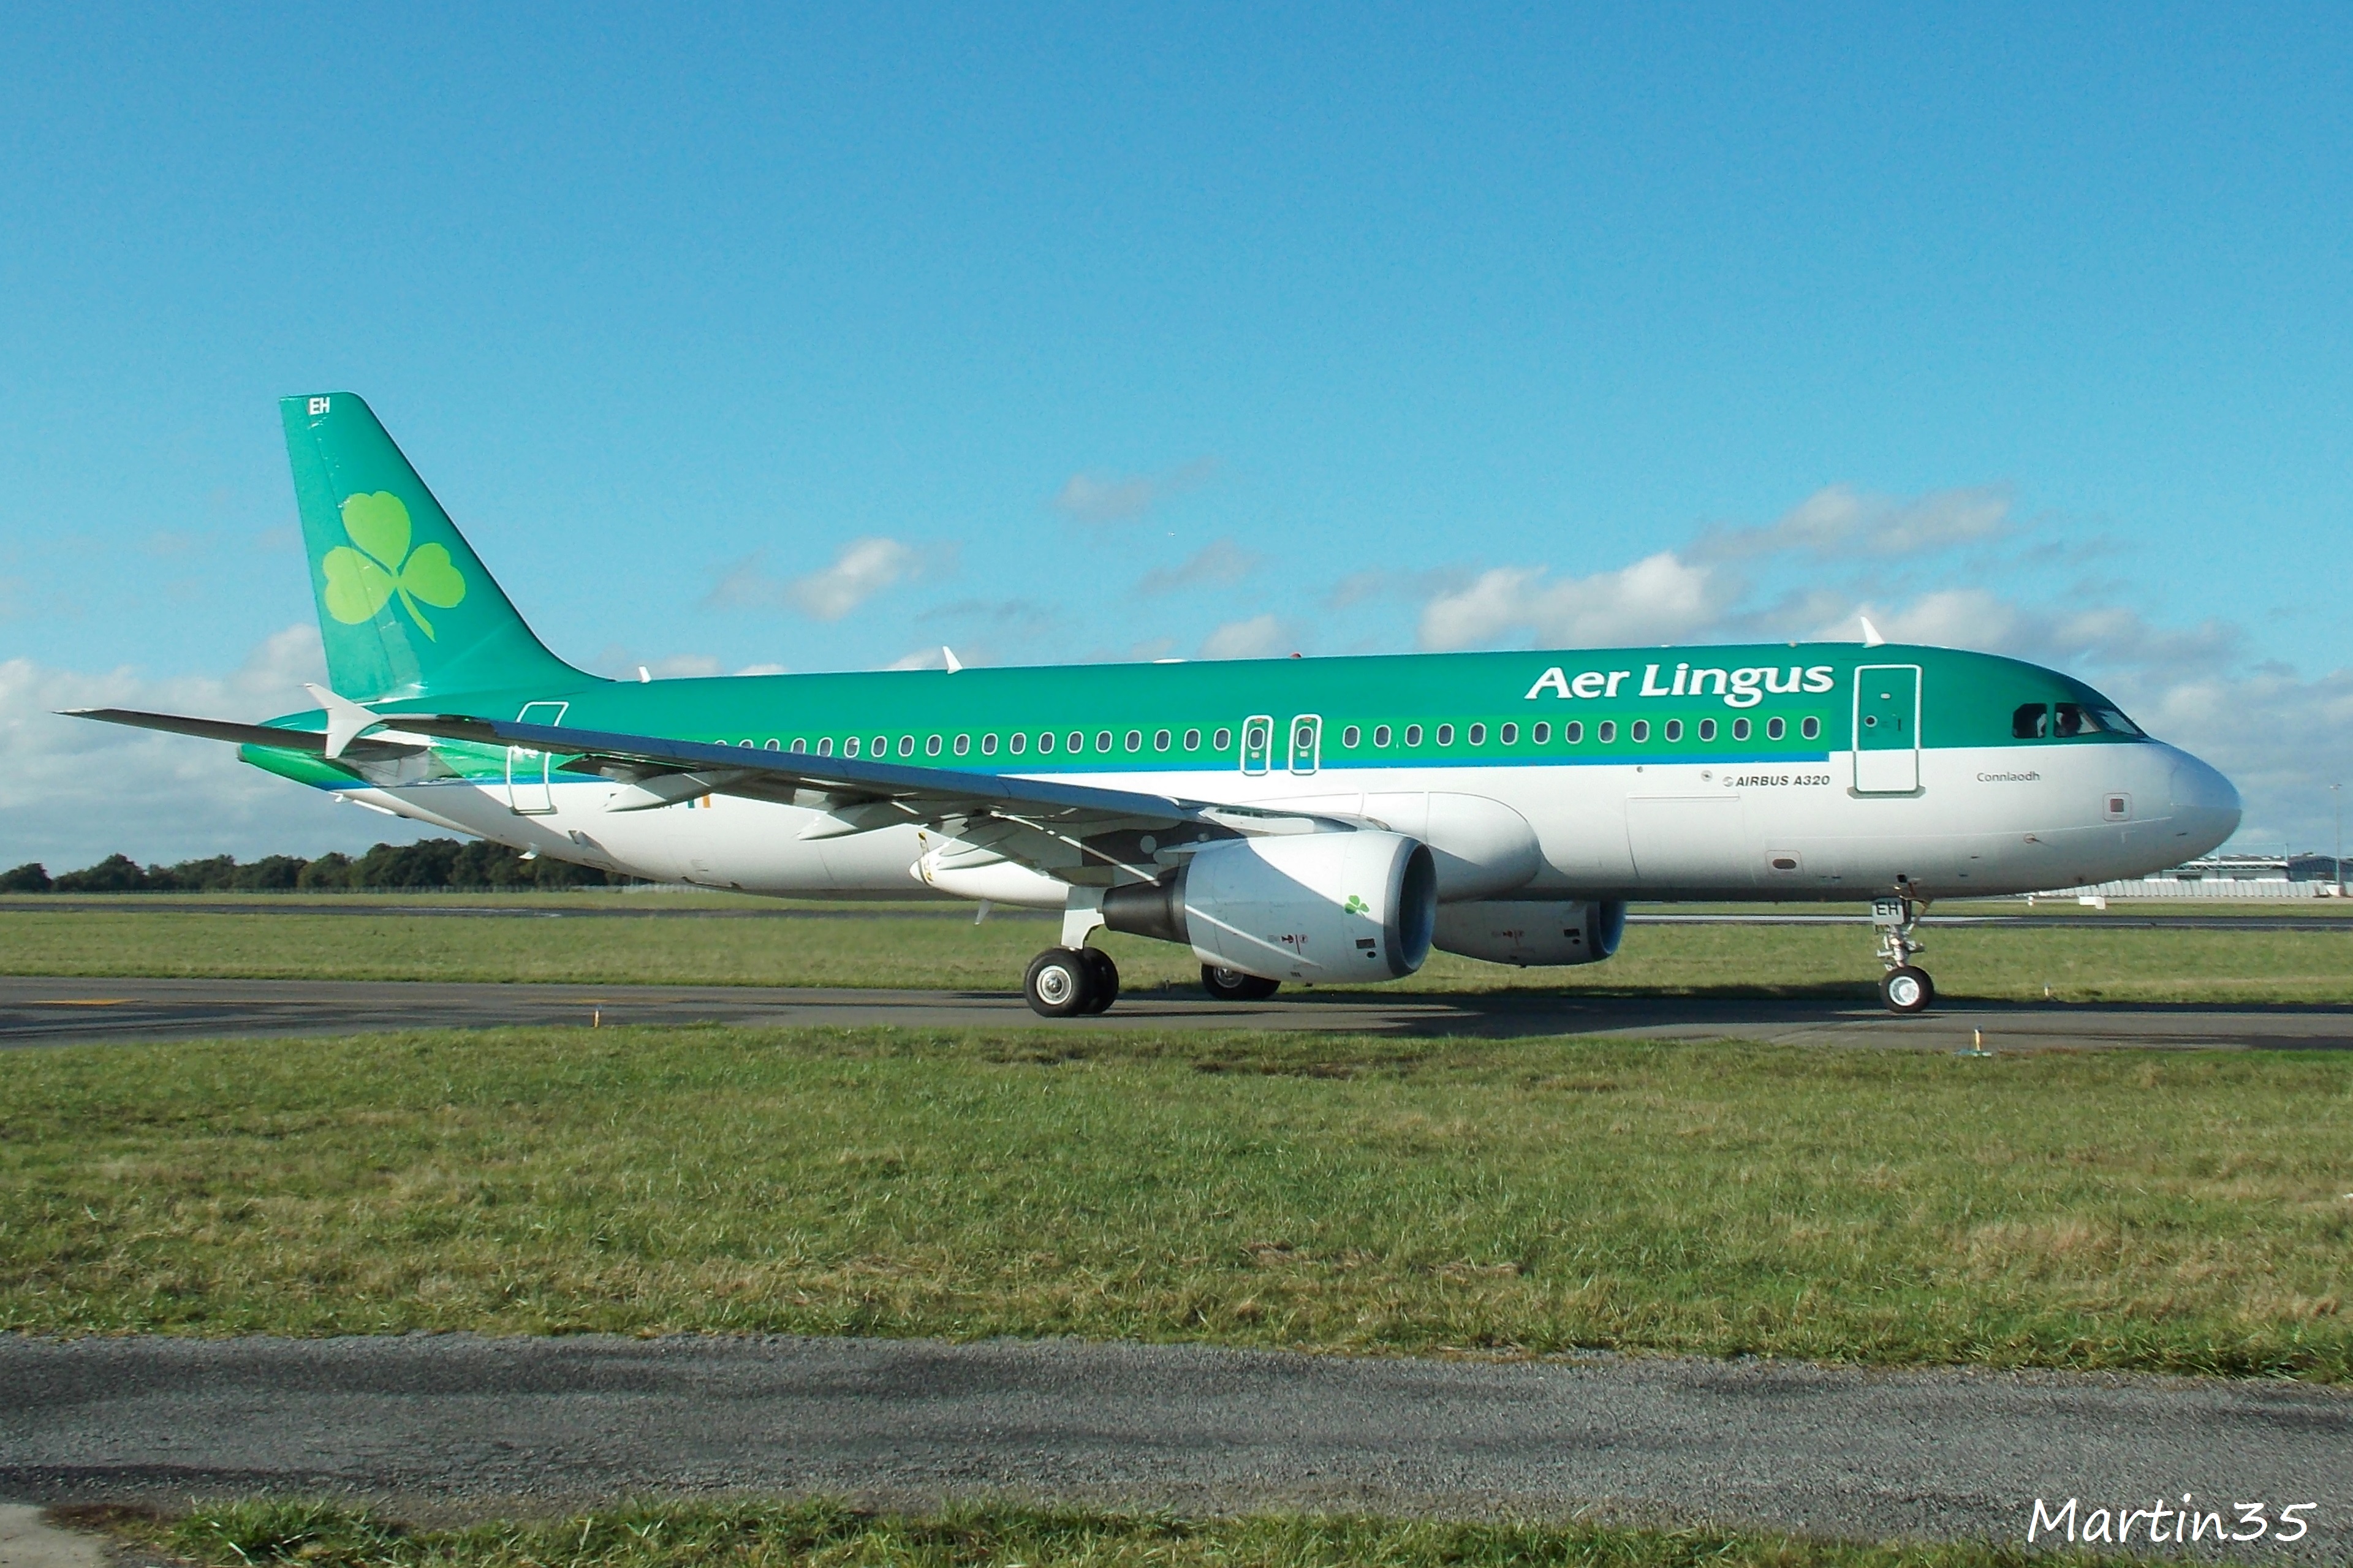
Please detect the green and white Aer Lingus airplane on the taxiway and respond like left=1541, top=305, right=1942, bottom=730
left=73, top=393, right=2240, bottom=1017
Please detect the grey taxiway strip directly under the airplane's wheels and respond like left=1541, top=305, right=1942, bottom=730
left=0, top=977, right=2353, bottom=1050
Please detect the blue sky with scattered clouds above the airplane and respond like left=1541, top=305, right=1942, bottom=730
left=0, top=5, right=2353, bottom=864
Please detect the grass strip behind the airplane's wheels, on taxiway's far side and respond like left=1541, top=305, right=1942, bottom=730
left=0, top=892, right=2353, bottom=1003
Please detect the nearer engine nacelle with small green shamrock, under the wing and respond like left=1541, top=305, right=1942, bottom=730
left=1104, top=831, right=1438, bottom=984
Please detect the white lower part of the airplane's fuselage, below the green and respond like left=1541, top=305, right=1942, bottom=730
left=341, top=741, right=2238, bottom=906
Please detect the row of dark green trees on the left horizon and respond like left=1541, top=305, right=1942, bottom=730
left=0, top=838, right=633, bottom=892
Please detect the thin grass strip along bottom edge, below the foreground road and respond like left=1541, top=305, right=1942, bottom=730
left=101, top=1502, right=2192, bottom=1568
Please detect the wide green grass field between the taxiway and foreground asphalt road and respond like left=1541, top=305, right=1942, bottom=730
left=0, top=1012, right=2353, bottom=1382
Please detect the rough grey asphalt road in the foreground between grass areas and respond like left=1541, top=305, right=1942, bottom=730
left=0, top=1335, right=2353, bottom=1561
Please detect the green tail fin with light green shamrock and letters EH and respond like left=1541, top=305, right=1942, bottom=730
left=278, top=393, right=593, bottom=702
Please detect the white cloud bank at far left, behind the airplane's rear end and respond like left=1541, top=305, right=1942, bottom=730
left=0, top=626, right=431, bottom=871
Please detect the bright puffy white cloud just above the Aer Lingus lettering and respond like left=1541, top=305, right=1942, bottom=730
left=1421, top=551, right=1741, bottom=650
